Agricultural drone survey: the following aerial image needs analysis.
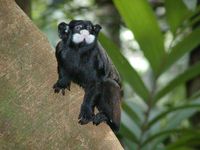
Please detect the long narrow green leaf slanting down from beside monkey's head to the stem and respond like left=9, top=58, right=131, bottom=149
left=99, top=34, right=149, bottom=100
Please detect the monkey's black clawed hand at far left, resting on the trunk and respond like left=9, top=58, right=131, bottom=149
left=53, top=79, right=70, bottom=95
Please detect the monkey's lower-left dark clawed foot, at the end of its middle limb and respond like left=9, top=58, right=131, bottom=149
left=78, top=106, right=94, bottom=125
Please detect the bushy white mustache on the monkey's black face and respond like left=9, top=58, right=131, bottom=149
left=72, top=29, right=95, bottom=44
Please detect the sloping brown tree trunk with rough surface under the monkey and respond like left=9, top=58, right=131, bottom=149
left=0, top=0, right=123, bottom=150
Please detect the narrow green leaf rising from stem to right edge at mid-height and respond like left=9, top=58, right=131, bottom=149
left=154, top=62, right=200, bottom=103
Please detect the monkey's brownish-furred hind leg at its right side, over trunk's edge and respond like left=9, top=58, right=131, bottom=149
left=103, top=79, right=121, bottom=132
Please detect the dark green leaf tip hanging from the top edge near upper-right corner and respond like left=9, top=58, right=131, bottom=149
left=165, top=0, right=190, bottom=34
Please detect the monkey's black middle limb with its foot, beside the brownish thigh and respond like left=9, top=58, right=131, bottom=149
left=78, top=86, right=98, bottom=124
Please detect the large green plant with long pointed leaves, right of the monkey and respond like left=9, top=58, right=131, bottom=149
left=100, top=0, right=200, bottom=150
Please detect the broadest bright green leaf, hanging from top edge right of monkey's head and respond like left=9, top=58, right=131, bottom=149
left=114, top=0, right=165, bottom=74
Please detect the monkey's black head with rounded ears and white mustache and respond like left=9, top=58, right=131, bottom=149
left=58, top=20, right=101, bottom=44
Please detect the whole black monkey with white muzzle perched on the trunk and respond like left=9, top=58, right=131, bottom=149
left=53, top=20, right=122, bottom=132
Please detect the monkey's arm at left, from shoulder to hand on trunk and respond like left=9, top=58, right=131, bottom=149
left=53, top=42, right=71, bottom=95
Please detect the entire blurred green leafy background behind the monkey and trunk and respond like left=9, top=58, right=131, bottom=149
left=18, top=0, right=200, bottom=150
